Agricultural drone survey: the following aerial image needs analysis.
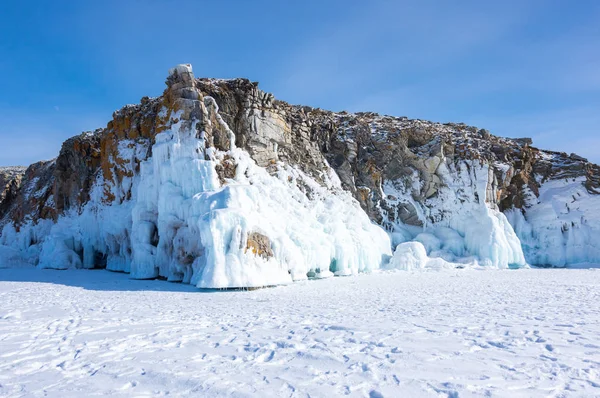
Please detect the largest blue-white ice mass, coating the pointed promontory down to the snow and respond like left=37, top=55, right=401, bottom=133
left=2, top=66, right=392, bottom=288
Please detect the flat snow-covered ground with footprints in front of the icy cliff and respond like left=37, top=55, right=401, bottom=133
left=0, top=269, right=600, bottom=397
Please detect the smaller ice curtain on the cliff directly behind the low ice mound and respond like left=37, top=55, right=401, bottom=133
left=382, top=158, right=527, bottom=268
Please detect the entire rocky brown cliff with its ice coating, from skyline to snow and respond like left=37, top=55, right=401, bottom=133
left=0, top=65, right=600, bottom=288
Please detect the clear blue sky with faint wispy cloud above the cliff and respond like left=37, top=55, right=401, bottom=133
left=0, top=0, right=600, bottom=165
